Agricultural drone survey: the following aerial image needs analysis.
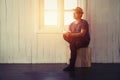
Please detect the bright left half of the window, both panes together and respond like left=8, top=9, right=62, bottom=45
left=44, top=0, right=58, bottom=26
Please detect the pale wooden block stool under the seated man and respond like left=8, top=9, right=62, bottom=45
left=75, top=47, right=91, bottom=67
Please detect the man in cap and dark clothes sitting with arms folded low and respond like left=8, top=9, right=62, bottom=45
left=63, top=7, right=90, bottom=71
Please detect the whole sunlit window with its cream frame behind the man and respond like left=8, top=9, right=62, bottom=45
left=34, top=0, right=86, bottom=33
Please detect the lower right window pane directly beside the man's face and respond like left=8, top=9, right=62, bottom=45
left=64, top=11, right=74, bottom=25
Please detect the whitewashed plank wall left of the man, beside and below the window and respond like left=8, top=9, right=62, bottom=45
left=0, top=0, right=67, bottom=63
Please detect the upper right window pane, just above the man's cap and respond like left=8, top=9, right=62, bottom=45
left=64, top=0, right=77, bottom=10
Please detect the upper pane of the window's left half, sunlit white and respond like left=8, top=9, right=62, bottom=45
left=44, top=0, right=57, bottom=9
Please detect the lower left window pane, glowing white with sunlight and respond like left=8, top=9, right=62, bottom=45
left=44, top=11, right=57, bottom=25
